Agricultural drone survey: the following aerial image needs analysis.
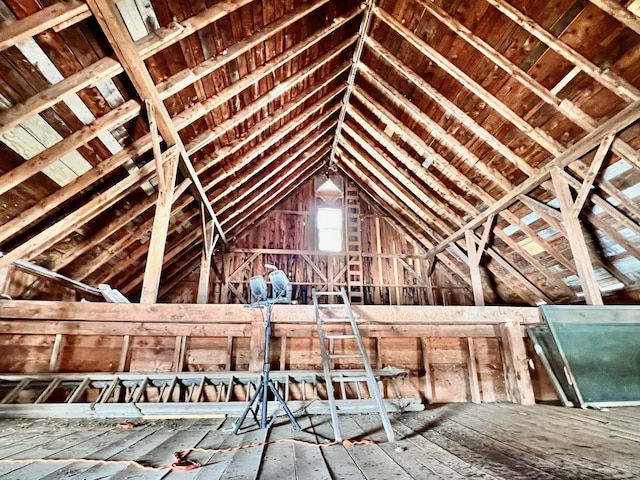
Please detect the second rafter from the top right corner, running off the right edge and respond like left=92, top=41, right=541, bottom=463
left=487, top=0, right=640, bottom=102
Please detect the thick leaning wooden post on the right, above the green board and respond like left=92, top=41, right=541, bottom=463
left=551, top=167, right=603, bottom=305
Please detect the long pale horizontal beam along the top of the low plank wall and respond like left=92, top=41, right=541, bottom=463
left=0, top=300, right=540, bottom=324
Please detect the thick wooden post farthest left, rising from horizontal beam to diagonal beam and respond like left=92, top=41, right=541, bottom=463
left=140, top=154, right=179, bottom=303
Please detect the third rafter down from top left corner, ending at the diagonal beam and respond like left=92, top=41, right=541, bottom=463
left=0, top=100, right=140, bottom=195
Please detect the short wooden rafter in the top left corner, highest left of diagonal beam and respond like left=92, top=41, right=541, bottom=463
left=0, top=0, right=91, bottom=51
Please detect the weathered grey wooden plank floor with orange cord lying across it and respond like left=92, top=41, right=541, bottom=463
left=0, top=404, right=640, bottom=480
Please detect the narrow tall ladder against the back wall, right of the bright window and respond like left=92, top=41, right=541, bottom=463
left=345, top=180, right=364, bottom=305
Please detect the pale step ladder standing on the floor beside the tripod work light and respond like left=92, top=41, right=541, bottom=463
left=313, top=288, right=394, bottom=442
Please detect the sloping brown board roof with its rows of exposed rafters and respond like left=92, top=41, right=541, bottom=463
left=0, top=0, right=640, bottom=301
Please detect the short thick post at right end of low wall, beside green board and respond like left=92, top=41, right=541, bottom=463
left=500, top=321, right=536, bottom=405
